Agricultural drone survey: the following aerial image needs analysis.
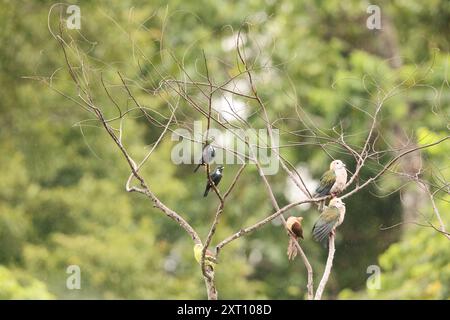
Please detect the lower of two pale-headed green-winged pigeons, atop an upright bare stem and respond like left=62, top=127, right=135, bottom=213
left=312, top=198, right=345, bottom=248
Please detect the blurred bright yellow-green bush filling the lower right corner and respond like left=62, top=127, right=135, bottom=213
left=339, top=211, right=450, bottom=300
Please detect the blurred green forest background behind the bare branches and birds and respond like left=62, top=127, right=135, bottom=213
left=0, top=0, right=450, bottom=299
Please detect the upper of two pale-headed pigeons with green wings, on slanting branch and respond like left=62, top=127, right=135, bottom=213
left=314, top=160, right=347, bottom=210
